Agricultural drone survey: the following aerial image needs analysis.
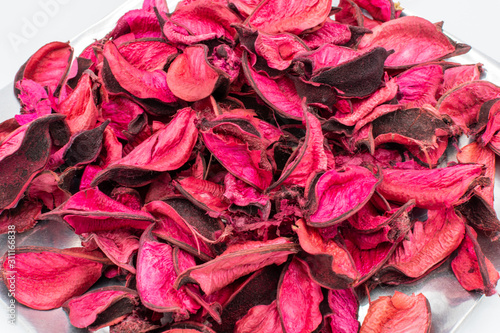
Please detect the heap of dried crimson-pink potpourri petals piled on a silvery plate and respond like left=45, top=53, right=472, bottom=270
left=0, top=0, right=500, bottom=333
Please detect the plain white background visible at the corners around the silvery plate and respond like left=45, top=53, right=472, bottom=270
left=0, top=0, right=500, bottom=333
